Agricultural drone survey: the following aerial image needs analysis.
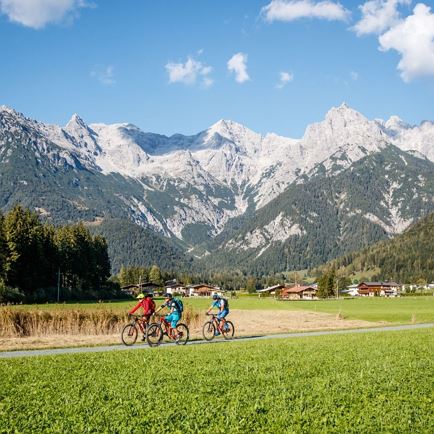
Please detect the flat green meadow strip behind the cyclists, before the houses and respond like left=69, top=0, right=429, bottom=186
left=12, top=296, right=434, bottom=323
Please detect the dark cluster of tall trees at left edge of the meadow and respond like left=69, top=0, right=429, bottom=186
left=0, top=205, right=118, bottom=302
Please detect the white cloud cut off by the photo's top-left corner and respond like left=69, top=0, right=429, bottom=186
left=0, top=0, right=92, bottom=29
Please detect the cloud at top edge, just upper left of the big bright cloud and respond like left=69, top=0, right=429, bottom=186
left=353, top=0, right=411, bottom=36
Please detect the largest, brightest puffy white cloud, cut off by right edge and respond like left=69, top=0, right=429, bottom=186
left=379, top=3, right=434, bottom=81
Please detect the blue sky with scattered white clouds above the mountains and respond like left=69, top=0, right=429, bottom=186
left=0, top=0, right=434, bottom=138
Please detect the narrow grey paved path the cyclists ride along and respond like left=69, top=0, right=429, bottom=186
left=0, top=323, right=434, bottom=359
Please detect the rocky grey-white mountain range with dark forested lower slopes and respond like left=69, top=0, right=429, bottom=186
left=0, top=104, right=434, bottom=274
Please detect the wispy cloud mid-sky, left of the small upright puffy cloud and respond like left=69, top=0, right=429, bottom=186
left=166, top=57, right=214, bottom=87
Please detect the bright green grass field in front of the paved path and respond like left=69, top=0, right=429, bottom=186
left=0, top=329, right=434, bottom=433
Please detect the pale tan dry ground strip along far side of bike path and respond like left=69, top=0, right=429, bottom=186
left=0, top=309, right=384, bottom=351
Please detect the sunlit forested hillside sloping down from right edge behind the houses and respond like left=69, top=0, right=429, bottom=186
left=317, top=213, right=434, bottom=283
